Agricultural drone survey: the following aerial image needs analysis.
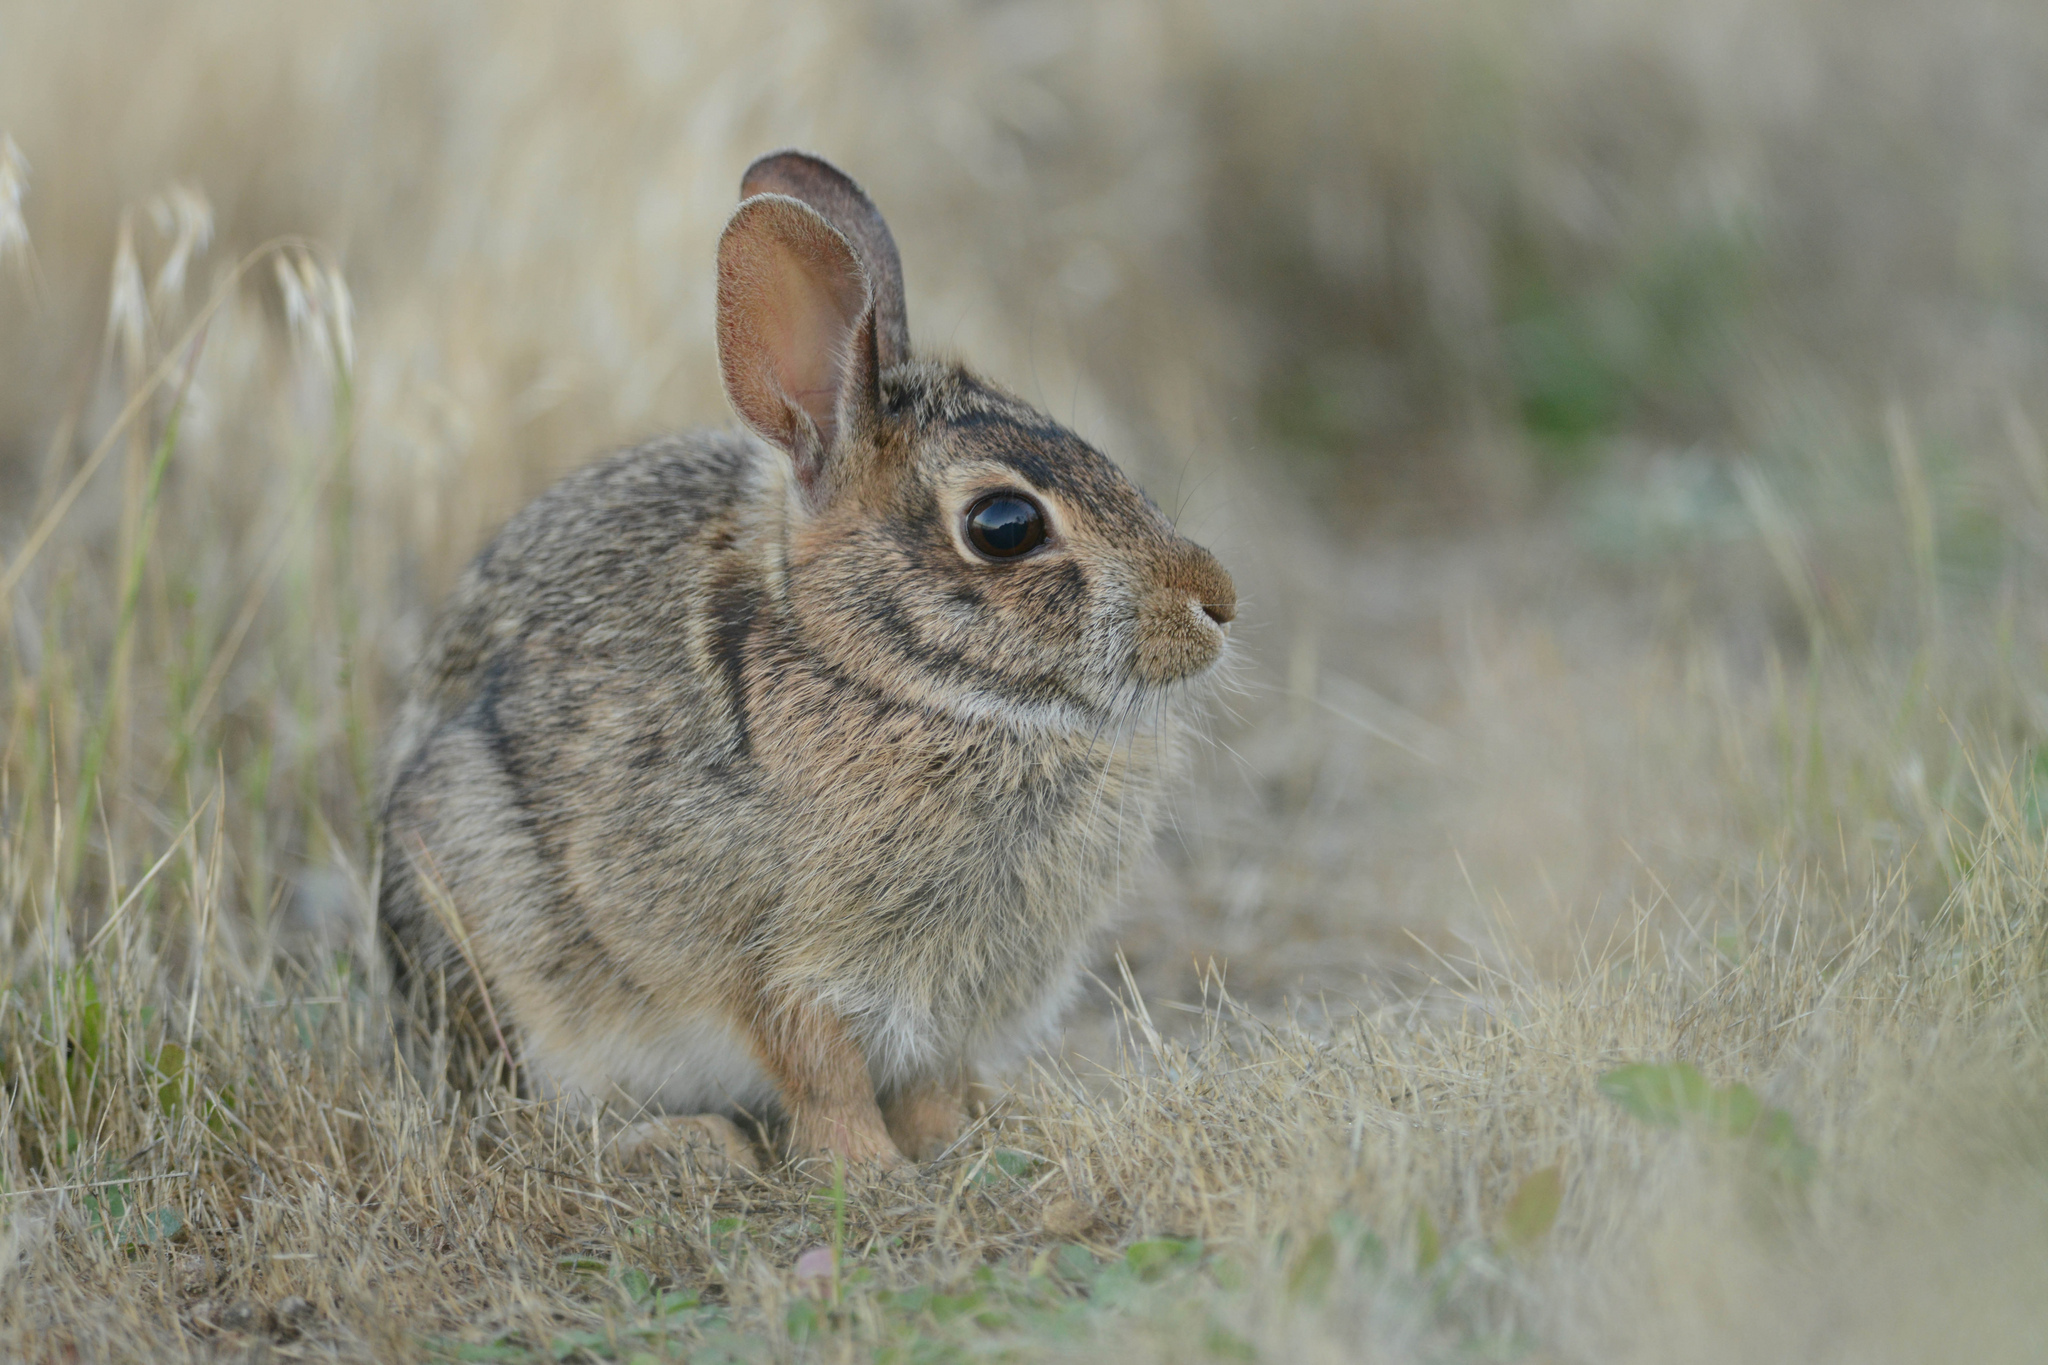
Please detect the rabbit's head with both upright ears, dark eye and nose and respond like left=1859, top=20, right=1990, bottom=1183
left=717, top=151, right=1237, bottom=731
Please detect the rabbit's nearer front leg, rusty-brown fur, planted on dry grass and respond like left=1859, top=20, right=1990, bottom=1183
left=756, top=1005, right=903, bottom=1166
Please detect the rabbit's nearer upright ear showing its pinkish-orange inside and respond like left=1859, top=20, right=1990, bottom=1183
left=719, top=194, right=877, bottom=495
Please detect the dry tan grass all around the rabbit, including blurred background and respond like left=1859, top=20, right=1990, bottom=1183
left=0, top=0, right=2048, bottom=1361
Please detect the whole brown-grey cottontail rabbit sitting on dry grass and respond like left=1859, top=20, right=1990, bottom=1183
left=379, top=151, right=1237, bottom=1171
